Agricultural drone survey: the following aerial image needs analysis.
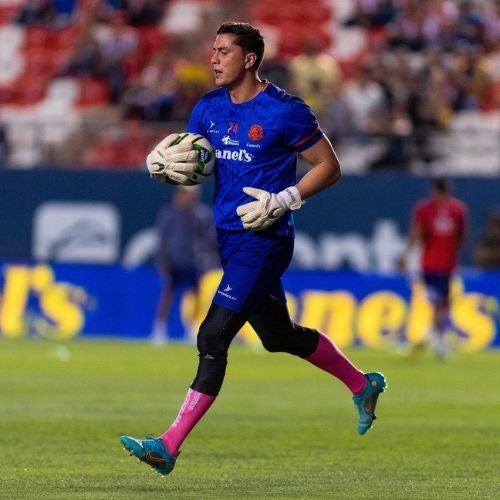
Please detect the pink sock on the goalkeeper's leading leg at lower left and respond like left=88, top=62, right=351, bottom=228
left=160, top=389, right=215, bottom=457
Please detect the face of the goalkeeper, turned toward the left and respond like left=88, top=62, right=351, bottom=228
left=211, top=34, right=246, bottom=87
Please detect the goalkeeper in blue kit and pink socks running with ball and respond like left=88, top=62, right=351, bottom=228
left=121, top=23, right=386, bottom=475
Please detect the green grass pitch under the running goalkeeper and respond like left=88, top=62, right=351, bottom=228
left=0, top=339, right=500, bottom=500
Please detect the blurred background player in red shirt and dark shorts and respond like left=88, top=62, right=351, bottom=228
left=399, top=179, right=467, bottom=357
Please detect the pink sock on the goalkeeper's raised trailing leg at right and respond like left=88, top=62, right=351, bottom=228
left=305, top=332, right=366, bottom=394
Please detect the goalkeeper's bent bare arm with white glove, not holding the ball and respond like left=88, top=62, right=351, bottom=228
left=236, top=135, right=340, bottom=231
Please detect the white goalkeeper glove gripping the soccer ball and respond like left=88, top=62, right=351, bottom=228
left=146, top=134, right=200, bottom=185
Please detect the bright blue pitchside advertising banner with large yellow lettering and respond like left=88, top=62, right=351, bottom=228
left=0, top=261, right=500, bottom=350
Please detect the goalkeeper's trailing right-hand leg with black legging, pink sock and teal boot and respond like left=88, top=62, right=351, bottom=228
left=249, top=291, right=387, bottom=434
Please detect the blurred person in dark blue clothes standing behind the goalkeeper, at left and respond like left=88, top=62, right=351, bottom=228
left=151, top=186, right=219, bottom=344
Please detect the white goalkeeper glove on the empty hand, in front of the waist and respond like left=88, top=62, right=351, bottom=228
left=236, top=186, right=303, bottom=231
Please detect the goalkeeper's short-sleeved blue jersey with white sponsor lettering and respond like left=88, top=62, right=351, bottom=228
left=187, top=83, right=322, bottom=235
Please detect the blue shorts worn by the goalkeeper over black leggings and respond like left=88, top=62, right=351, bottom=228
left=213, top=229, right=294, bottom=313
